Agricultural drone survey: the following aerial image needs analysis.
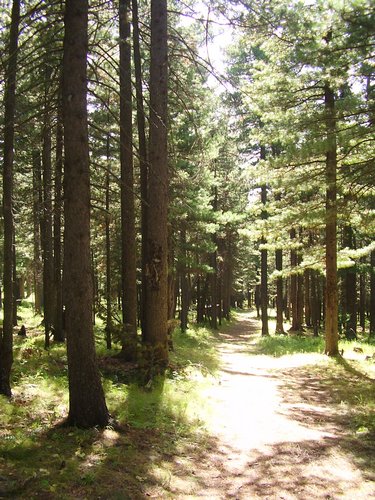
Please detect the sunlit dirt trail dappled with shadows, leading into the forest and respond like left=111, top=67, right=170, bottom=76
left=147, top=314, right=375, bottom=500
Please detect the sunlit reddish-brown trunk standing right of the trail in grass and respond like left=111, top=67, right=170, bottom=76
left=324, top=84, right=339, bottom=356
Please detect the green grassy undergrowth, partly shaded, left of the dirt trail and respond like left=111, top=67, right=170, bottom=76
left=0, top=319, right=219, bottom=499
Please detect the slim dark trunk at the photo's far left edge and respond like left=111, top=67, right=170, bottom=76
left=0, top=0, right=20, bottom=397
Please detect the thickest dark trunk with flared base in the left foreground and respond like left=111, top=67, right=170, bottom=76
left=63, top=0, right=108, bottom=427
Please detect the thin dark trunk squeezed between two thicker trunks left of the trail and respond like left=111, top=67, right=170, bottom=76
left=132, top=0, right=148, bottom=332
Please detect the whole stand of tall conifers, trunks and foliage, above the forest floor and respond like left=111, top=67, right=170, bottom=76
left=0, top=0, right=375, bottom=427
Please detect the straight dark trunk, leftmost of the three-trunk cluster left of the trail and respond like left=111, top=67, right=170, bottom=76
left=119, top=0, right=137, bottom=361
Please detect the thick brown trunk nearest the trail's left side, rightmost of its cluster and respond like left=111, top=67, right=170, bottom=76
left=142, top=0, right=168, bottom=372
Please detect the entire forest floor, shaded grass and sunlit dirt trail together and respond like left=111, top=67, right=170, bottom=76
left=0, top=312, right=375, bottom=500
